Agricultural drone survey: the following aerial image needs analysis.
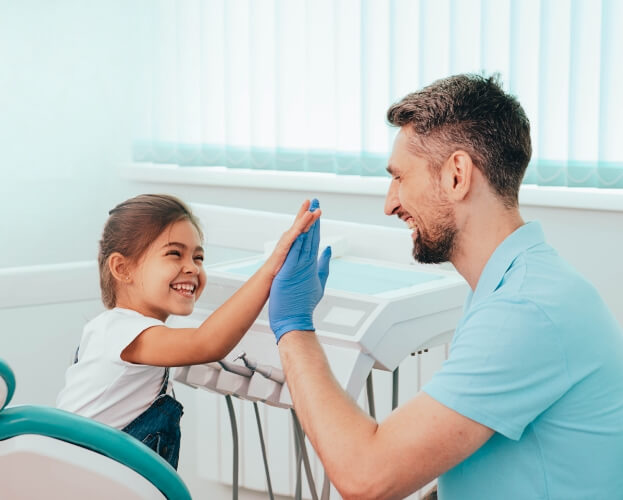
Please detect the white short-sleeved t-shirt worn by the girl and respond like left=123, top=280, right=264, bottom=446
left=56, top=307, right=170, bottom=429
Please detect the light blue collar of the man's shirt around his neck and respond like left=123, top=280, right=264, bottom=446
left=466, top=222, right=545, bottom=309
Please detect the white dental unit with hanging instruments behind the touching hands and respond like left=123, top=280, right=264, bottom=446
left=175, top=204, right=467, bottom=498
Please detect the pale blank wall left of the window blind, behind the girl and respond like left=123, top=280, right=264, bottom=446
left=0, top=0, right=151, bottom=267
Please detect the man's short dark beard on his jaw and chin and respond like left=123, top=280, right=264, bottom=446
left=413, top=209, right=457, bottom=264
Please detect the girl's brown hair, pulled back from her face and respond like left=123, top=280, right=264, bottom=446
left=97, top=194, right=203, bottom=309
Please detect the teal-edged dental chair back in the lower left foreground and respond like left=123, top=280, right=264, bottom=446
left=0, top=359, right=191, bottom=500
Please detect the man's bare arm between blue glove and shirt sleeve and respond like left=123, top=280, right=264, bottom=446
left=279, top=331, right=493, bottom=499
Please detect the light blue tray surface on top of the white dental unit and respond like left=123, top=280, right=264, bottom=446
left=222, top=259, right=443, bottom=295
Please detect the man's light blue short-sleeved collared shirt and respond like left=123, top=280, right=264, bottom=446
left=424, top=222, right=623, bottom=500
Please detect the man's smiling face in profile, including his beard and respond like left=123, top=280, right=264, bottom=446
left=385, top=127, right=457, bottom=264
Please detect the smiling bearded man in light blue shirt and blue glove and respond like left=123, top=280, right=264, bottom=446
left=270, top=75, right=623, bottom=500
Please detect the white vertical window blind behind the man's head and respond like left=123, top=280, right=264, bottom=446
left=133, top=0, right=623, bottom=188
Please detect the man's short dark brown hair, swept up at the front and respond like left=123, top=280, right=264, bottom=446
left=387, top=74, right=532, bottom=207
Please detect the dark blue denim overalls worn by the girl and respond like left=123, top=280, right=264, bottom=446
left=121, top=368, right=184, bottom=470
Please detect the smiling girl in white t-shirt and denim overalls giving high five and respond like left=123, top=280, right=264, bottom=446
left=57, top=194, right=320, bottom=468
